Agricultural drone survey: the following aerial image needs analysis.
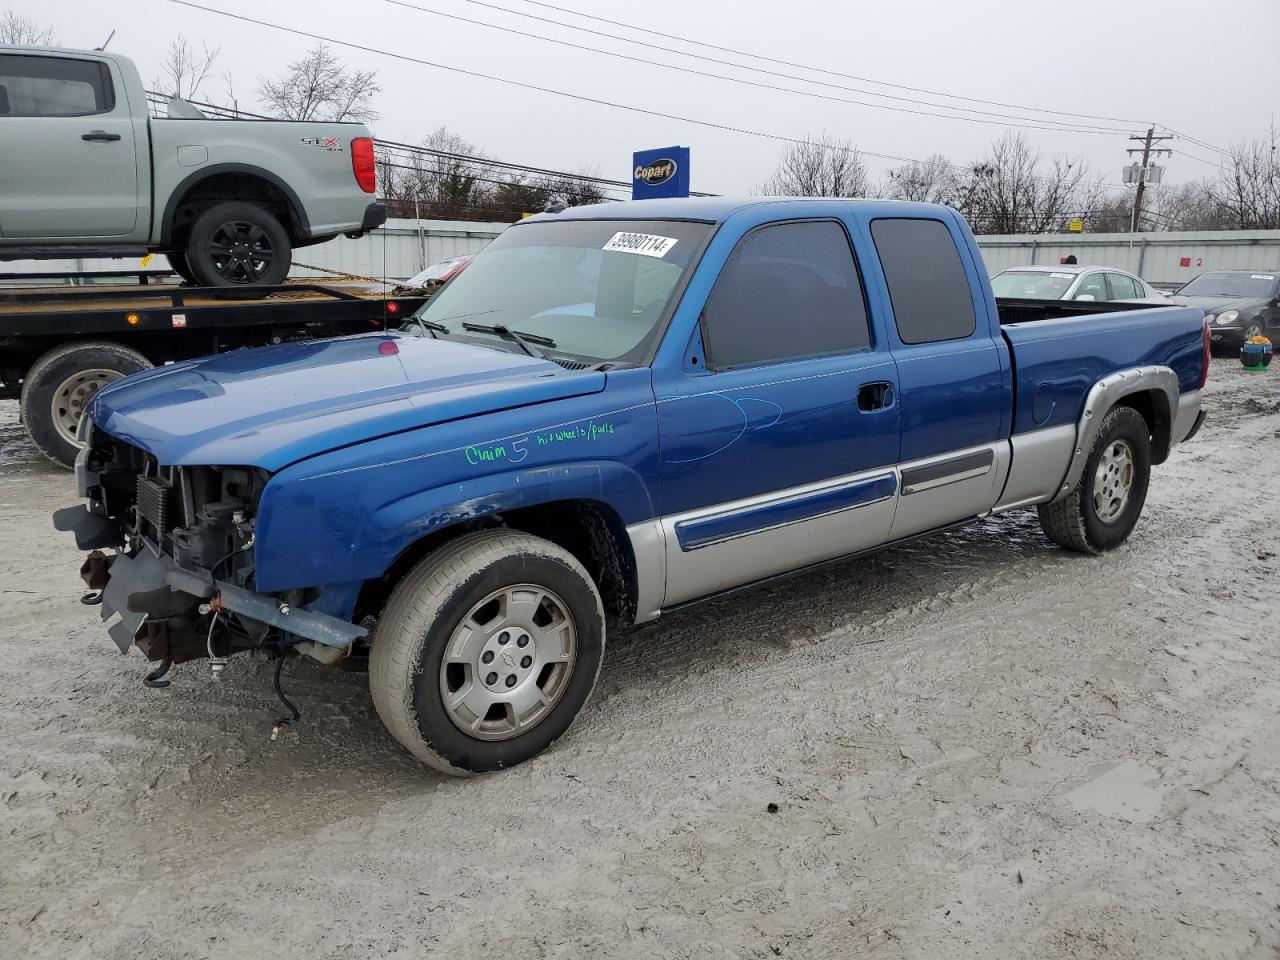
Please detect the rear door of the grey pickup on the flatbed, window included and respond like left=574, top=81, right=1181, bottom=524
left=0, top=52, right=140, bottom=241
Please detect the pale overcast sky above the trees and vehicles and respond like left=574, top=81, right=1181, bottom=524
left=10, top=0, right=1280, bottom=193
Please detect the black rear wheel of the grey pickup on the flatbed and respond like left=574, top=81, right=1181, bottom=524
left=183, top=202, right=293, bottom=289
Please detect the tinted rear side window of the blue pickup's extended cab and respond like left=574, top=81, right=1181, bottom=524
left=872, top=219, right=978, bottom=343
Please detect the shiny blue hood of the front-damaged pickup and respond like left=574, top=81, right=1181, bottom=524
left=88, top=333, right=605, bottom=471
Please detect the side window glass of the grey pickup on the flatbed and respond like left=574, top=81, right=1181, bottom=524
left=0, top=54, right=115, bottom=116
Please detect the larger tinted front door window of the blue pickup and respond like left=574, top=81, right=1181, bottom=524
left=703, top=220, right=870, bottom=370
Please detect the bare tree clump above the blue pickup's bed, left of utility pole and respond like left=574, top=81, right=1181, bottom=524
left=957, top=132, right=1102, bottom=233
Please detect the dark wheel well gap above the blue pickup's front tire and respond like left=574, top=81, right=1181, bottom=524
left=355, top=500, right=636, bottom=632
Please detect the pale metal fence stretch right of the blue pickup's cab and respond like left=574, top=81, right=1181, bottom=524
left=978, top=230, right=1280, bottom=289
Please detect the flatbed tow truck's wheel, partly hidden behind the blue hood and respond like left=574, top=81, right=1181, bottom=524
left=20, top=342, right=151, bottom=467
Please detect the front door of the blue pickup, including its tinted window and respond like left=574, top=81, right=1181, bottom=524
left=654, top=219, right=900, bottom=607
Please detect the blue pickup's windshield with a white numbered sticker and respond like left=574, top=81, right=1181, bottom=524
left=406, top=220, right=712, bottom=362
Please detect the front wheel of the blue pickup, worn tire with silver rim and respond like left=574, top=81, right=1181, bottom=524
left=369, top=530, right=604, bottom=776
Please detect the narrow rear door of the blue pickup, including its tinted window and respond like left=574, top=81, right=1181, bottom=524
left=869, top=216, right=1011, bottom=539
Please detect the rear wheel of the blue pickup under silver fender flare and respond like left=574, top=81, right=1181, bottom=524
left=1039, top=407, right=1151, bottom=553
